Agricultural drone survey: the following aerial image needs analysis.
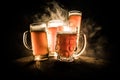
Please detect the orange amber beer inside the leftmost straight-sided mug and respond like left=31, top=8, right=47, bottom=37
left=31, top=28, right=48, bottom=56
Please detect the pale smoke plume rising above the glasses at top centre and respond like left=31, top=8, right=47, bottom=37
left=33, top=1, right=68, bottom=22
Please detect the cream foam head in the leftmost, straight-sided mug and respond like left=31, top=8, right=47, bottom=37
left=30, top=23, right=46, bottom=31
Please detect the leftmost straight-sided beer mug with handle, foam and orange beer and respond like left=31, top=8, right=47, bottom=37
left=23, top=22, right=49, bottom=61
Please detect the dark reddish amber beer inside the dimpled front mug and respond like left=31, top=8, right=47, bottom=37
left=56, top=32, right=77, bottom=59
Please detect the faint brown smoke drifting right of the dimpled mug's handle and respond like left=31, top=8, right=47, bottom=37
left=81, top=18, right=108, bottom=59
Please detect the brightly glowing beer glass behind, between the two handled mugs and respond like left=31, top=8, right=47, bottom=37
left=47, top=20, right=63, bottom=57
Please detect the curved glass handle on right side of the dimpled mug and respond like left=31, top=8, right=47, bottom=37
left=74, top=33, right=87, bottom=58
